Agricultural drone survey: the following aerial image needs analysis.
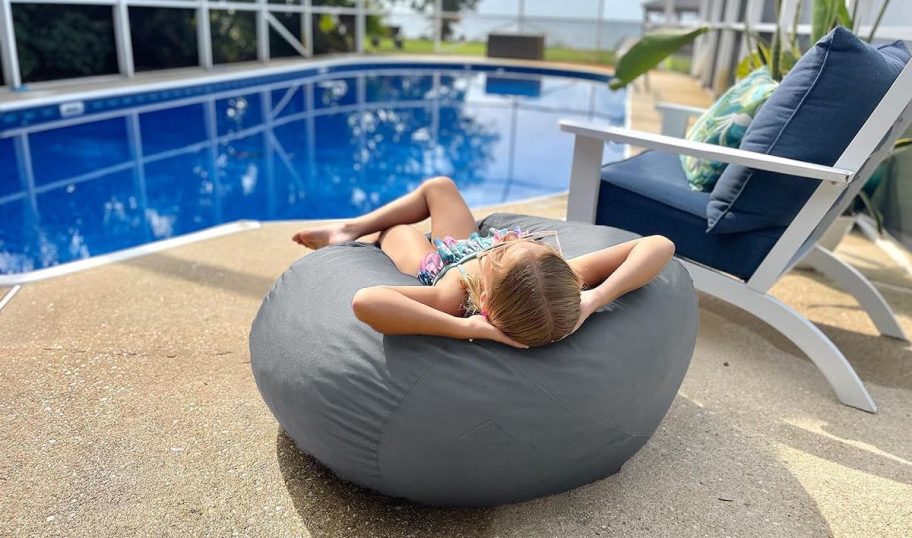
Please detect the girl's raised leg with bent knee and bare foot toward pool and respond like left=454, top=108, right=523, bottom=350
left=292, top=177, right=478, bottom=248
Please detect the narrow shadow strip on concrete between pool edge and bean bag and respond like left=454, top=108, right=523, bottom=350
left=122, top=252, right=274, bottom=300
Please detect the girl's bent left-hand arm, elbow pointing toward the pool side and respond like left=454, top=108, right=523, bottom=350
left=352, top=286, right=528, bottom=348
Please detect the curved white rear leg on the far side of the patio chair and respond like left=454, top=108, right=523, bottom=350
left=804, top=245, right=909, bottom=341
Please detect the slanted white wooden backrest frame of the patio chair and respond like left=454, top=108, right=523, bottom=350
left=748, top=61, right=912, bottom=291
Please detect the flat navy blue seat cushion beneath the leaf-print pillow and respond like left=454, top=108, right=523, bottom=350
left=595, top=151, right=784, bottom=280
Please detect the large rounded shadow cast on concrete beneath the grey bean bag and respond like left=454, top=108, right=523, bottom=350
left=276, top=396, right=832, bottom=538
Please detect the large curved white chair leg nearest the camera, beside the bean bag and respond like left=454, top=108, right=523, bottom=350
left=684, top=262, right=877, bottom=413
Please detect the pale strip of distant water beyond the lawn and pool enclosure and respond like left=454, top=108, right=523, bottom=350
left=384, top=14, right=642, bottom=50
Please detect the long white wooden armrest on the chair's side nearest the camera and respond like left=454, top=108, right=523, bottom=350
left=560, top=120, right=855, bottom=184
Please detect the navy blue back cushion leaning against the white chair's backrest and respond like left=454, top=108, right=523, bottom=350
left=706, top=27, right=909, bottom=233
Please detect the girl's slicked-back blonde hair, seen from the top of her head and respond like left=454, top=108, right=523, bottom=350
left=462, top=245, right=583, bottom=346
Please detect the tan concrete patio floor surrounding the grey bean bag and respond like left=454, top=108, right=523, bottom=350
left=0, top=73, right=912, bottom=537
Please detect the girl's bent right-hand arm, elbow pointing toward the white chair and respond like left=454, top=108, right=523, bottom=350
left=567, top=235, right=674, bottom=327
